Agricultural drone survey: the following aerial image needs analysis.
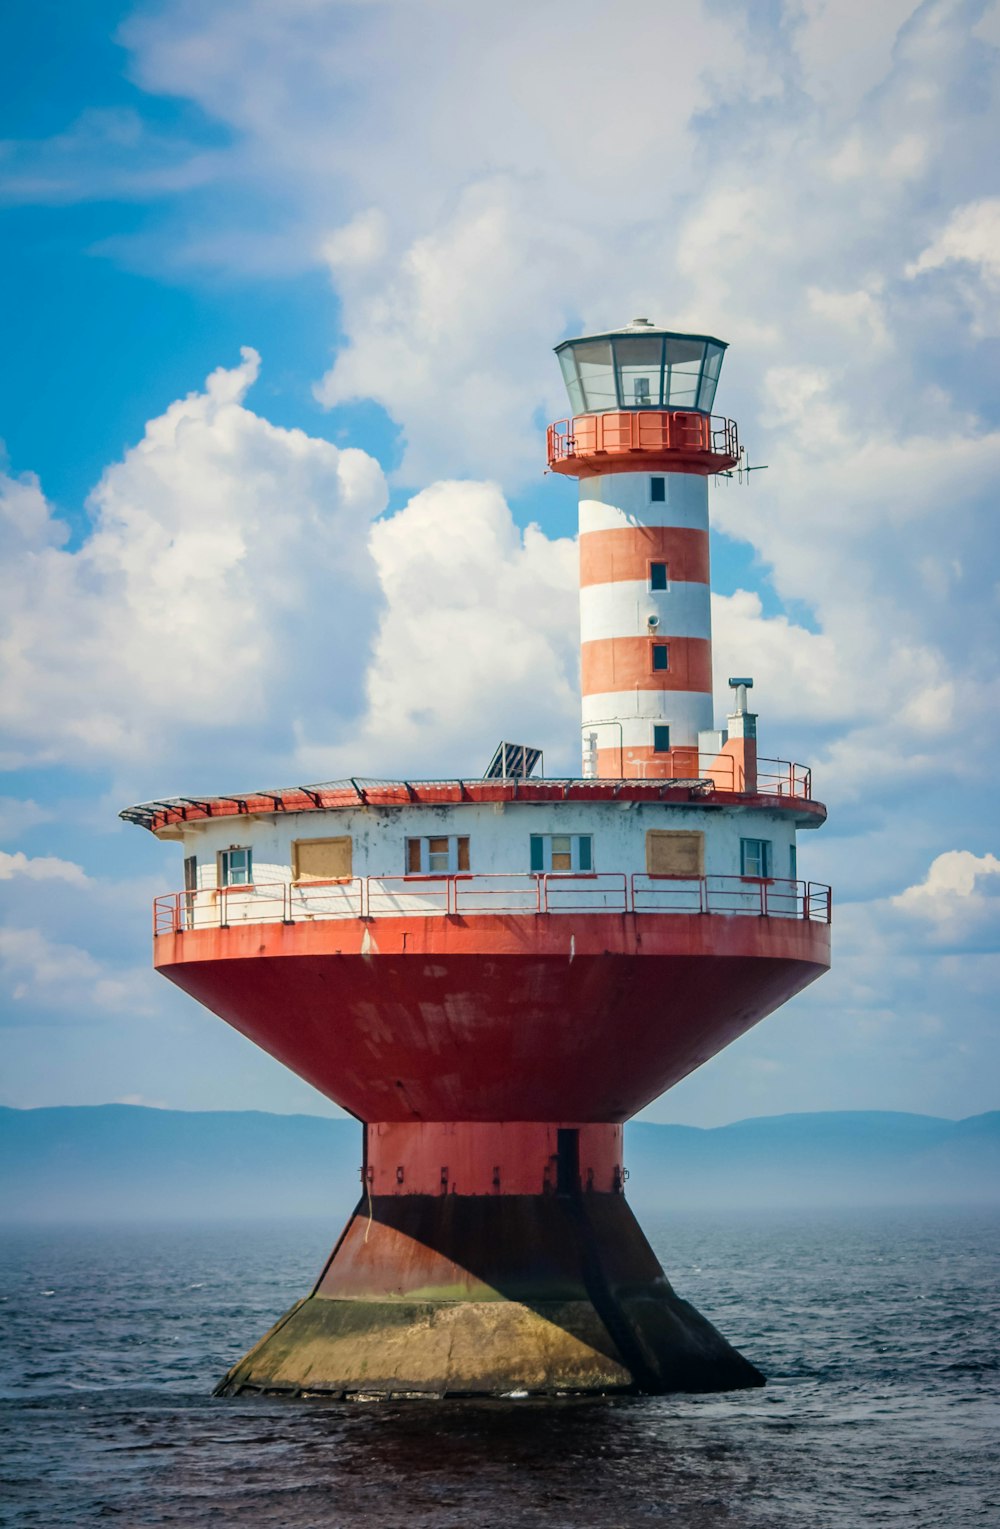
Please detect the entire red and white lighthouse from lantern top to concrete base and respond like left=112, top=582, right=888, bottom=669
left=122, top=320, right=830, bottom=1398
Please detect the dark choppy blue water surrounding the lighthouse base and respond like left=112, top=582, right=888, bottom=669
left=0, top=1209, right=1000, bottom=1529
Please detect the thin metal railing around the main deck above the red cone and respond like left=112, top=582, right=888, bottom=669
left=153, top=872, right=832, bottom=936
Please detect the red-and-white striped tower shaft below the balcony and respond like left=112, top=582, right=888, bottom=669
left=580, top=472, right=713, bottom=778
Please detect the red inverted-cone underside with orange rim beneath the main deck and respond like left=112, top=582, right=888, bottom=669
left=154, top=905, right=830, bottom=1122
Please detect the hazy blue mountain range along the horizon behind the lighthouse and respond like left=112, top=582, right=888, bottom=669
left=0, top=1104, right=1000, bottom=1222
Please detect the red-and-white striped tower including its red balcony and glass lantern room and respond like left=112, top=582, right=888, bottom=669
left=549, top=318, right=739, bottom=780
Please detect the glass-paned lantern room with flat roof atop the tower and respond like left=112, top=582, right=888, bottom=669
left=555, top=318, right=726, bottom=414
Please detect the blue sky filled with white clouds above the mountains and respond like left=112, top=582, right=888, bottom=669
left=0, top=0, right=1000, bottom=1125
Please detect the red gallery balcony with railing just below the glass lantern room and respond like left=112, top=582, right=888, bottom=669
left=546, top=408, right=740, bottom=479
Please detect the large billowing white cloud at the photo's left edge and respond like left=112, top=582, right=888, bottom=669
left=0, top=352, right=385, bottom=790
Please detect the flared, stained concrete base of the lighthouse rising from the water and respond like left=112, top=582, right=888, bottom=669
left=217, top=1194, right=763, bottom=1396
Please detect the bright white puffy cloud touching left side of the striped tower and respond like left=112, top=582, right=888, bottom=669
left=303, top=482, right=580, bottom=777
